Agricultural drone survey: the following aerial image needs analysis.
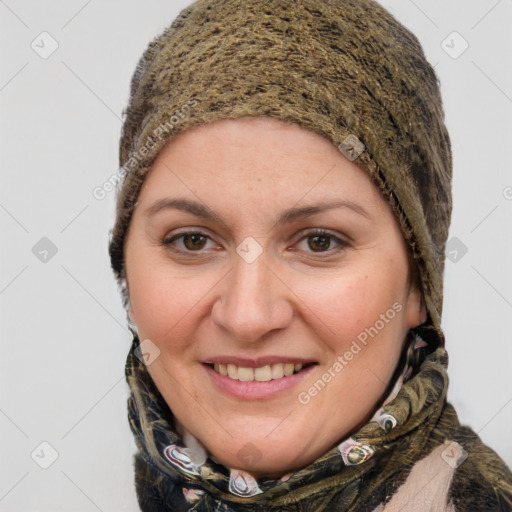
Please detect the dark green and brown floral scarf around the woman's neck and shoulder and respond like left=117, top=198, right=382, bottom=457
left=125, top=329, right=512, bottom=512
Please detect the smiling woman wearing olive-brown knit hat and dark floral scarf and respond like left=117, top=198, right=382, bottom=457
left=110, top=0, right=512, bottom=512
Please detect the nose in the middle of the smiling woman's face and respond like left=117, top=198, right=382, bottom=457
left=211, top=249, right=294, bottom=342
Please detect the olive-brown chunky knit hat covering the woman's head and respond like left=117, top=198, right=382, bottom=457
left=109, top=0, right=452, bottom=350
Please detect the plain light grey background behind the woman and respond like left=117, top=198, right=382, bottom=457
left=0, top=0, right=512, bottom=512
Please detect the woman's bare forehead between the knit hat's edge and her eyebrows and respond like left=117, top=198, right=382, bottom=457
left=136, top=117, right=382, bottom=207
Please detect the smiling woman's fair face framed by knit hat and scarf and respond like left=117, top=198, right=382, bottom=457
left=125, top=118, right=421, bottom=477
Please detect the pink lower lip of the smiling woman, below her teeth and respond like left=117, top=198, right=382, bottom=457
left=203, top=364, right=317, bottom=400
